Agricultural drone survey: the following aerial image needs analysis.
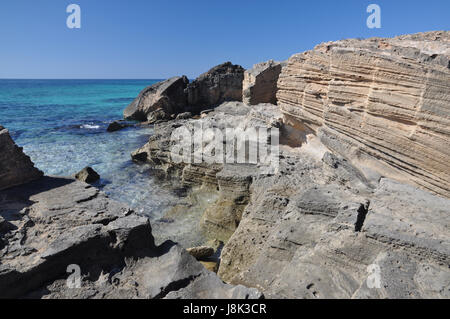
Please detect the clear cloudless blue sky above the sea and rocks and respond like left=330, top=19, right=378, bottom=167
left=0, top=0, right=450, bottom=79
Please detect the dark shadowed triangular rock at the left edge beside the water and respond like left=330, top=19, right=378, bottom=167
left=0, top=126, right=43, bottom=190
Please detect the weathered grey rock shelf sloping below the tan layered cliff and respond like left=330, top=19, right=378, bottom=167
left=133, top=97, right=450, bottom=298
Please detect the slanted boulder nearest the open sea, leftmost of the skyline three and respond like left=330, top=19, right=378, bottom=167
left=123, top=76, right=189, bottom=121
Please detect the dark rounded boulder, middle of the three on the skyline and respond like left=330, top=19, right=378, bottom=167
left=186, top=62, right=245, bottom=113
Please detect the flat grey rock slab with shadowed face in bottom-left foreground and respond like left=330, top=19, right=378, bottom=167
left=0, top=127, right=262, bottom=298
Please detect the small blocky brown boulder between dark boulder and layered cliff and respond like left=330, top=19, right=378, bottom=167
left=242, top=60, right=282, bottom=105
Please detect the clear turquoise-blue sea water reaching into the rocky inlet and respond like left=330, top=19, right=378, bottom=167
left=0, top=80, right=212, bottom=246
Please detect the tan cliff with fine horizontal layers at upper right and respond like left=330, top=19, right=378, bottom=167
left=277, top=31, right=450, bottom=197
